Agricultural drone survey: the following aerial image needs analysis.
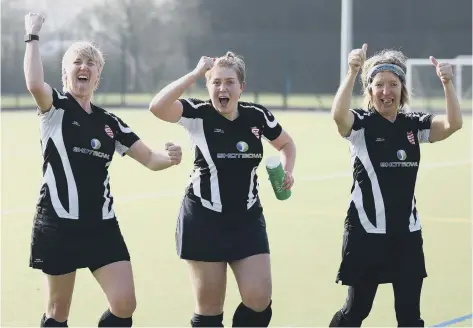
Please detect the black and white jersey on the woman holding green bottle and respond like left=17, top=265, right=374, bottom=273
left=178, top=98, right=282, bottom=213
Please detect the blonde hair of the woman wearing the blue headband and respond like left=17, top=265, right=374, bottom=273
left=360, top=49, right=409, bottom=109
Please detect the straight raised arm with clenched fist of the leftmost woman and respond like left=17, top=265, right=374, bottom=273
left=23, top=13, right=53, bottom=113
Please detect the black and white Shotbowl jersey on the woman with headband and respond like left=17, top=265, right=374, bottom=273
left=345, top=109, right=433, bottom=234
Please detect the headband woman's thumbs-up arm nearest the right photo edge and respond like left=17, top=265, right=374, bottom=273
left=429, top=57, right=463, bottom=142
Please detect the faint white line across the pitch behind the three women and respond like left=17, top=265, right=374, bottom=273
left=2, top=160, right=472, bottom=216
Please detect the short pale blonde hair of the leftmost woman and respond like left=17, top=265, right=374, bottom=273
left=62, top=41, right=105, bottom=92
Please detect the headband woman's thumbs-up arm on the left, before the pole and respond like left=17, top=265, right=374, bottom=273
left=332, top=43, right=368, bottom=137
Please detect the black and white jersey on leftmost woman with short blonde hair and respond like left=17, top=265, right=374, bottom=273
left=37, top=89, right=139, bottom=224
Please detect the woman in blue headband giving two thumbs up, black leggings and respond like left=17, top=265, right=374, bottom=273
left=330, top=44, right=462, bottom=327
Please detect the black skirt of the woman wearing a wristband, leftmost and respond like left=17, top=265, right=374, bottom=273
left=30, top=215, right=130, bottom=275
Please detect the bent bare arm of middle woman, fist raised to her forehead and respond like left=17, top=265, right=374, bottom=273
left=149, top=57, right=214, bottom=123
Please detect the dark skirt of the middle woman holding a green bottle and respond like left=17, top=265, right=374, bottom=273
left=176, top=196, right=269, bottom=262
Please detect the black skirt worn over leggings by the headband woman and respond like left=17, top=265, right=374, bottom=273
left=336, top=230, right=427, bottom=286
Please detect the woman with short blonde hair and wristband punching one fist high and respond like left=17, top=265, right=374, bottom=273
left=24, top=13, right=181, bottom=327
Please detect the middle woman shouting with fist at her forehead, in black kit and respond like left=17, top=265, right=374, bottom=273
left=150, top=52, right=296, bottom=327
